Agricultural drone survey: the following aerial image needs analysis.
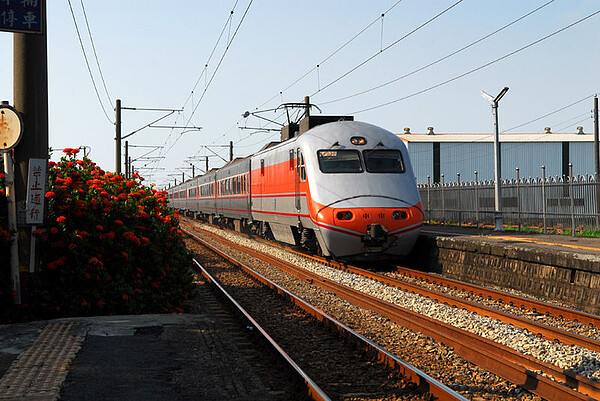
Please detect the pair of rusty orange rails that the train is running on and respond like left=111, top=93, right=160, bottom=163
left=182, top=219, right=600, bottom=399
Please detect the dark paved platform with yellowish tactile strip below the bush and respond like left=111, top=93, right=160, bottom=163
left=0, top=306, right=269, bottom=401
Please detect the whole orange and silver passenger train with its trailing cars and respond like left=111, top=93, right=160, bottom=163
left=167, top=117, right=423, bottom=260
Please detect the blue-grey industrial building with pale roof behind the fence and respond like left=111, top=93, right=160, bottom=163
left=397, top=127, right=594, bottom=183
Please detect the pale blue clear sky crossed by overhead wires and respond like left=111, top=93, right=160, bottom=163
left=0, top=0, right=600, bottom=187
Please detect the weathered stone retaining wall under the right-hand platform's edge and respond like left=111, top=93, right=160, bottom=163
left=410, top=235, right=600, bottom=314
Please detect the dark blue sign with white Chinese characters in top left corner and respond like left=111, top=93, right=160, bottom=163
left=0, top=0, right=46, bottom=34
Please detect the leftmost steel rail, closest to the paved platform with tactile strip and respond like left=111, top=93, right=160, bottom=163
left=193, top=259, right=331, bottom=401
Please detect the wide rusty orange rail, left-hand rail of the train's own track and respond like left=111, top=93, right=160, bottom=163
left=183, top=225, right=600, bottom=400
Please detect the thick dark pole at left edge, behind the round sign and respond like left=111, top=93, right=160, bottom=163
left=13, top=0, right=48, bottom=290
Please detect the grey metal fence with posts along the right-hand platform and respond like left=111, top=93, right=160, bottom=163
left=418, top=166, right=600, bottom=235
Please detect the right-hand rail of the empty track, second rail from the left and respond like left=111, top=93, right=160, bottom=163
left=184, top=229, right=467, bottom=401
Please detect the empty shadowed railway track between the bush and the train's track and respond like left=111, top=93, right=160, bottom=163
left=185, top=228, right=465, bottom=400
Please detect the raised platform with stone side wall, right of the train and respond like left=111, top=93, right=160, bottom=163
left=409, top=225, right=600, bottom=314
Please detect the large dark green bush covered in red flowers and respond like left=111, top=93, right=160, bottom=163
left=32, top=148, right=192, bottom=317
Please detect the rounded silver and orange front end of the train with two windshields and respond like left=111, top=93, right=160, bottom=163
left=298, top=121, right=423, bottom=259
